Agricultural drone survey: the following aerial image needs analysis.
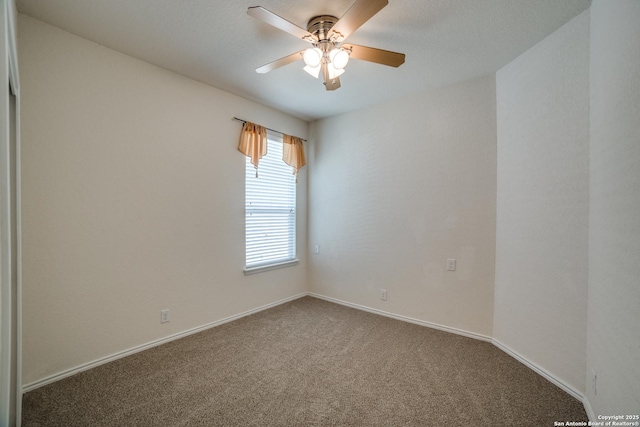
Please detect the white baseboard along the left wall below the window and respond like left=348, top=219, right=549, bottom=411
left=22, top=292, right=307, bottom=394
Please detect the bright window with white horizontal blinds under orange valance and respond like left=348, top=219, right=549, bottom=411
left=245, top=133, right=298, bottom=274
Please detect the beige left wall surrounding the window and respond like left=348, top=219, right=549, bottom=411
left=19, top=16, right=307, bottom=385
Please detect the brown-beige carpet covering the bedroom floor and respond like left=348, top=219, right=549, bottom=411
left=23, top=297, right=587, bottom=427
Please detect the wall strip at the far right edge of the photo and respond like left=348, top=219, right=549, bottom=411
left=586, top=0, right=640, bottom=416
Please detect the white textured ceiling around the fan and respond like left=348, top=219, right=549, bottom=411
left=16, top=0, right=590, bottom=120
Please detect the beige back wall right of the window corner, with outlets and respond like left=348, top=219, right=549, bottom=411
left=309, top=76, right=496, bottom=336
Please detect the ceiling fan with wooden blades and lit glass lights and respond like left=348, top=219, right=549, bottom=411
left=247, top=0, right=404, bottom=90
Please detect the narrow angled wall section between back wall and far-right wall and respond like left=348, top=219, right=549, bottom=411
left=494, top=11, right=589, bottom=394
